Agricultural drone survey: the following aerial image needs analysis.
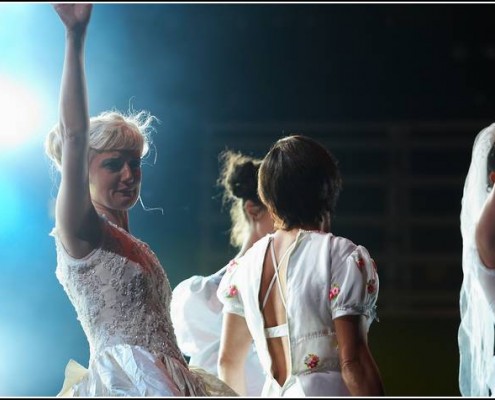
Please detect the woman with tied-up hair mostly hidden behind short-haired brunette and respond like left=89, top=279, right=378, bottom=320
left=170, top=150, right=273, bottom=396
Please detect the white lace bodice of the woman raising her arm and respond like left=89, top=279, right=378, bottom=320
left=52, top=219, right=186, bottom=365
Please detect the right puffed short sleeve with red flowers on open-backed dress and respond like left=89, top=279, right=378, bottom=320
left=328, top=246, right=379, bottom=323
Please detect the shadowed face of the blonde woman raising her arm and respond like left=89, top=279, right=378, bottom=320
left=89, top=150, right=141, bottom=210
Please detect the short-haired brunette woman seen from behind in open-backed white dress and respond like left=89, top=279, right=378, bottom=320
left=217, top=135, right=384, bottom=398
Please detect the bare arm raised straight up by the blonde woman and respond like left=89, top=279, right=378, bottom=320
left=53, top=3, right=99, bottom=258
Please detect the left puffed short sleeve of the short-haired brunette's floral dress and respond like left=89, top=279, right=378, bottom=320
left=217, top=259, right=244, bottom=317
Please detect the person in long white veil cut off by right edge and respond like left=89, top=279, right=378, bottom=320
left=458, top=124, right=495, bottom=397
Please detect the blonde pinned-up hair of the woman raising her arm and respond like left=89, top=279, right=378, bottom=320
left=45, top=110, right=158, bottom=170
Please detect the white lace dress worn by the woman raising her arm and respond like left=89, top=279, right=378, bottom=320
left=51, top=219, right=235, bottom=397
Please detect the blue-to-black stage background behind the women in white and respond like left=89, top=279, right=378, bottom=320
left=0, top=3, right=495, bottom=396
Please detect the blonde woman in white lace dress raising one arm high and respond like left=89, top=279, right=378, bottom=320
left=46, top=3, right=236, bottom=397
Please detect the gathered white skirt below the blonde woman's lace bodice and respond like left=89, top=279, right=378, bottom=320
left=57, top=344, right=238, bottom=397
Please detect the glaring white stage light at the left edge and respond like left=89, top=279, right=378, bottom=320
left=0, top=76, right=42, bottom=151
